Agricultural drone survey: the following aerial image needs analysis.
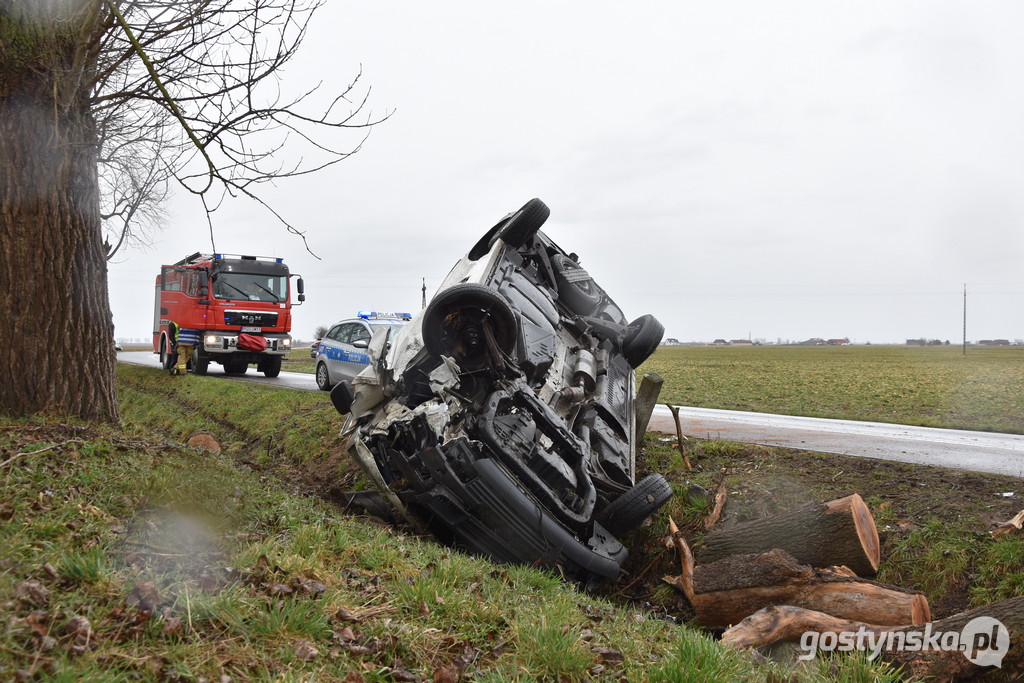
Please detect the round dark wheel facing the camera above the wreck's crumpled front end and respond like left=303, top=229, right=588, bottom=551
left=423, top=283, right=517, bottom=361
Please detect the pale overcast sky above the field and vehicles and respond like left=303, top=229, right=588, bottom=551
left=111, top=0, right=1024, bottom=343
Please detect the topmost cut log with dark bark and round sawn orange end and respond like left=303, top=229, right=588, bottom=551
left=697, top=494, right=881, bottom=577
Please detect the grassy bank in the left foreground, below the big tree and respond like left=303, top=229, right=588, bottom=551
left=0, top=367, right=921, bottom=682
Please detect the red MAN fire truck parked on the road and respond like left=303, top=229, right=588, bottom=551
left=153, top=253, right=306, bottom=377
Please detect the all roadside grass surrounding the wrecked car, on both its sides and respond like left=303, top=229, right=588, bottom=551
left=0, top=366, right=1024, bottom=683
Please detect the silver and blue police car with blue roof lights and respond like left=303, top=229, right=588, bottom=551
left=315, top=310, right=413, bottom=391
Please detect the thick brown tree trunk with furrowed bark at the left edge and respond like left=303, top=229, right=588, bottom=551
left=0, top=0, right=118, bottom=422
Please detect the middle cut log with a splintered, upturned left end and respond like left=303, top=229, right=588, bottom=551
left=665, top=520, right=931, bottom=628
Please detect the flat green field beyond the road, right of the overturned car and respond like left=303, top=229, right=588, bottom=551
left=637, top=345, right=1024, bottom=434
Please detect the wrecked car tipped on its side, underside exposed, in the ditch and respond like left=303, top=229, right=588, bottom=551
left=331, top=199, right=672, bottom=586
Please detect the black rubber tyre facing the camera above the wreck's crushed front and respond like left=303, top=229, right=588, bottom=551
left=423, top=283, right=518, bottom=360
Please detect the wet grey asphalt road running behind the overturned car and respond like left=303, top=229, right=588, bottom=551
left=118, top=351, right=1024, bottom=477
